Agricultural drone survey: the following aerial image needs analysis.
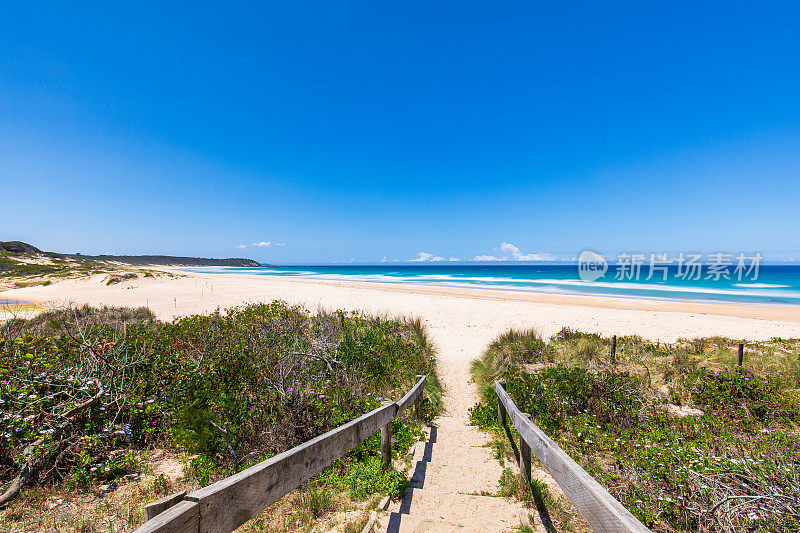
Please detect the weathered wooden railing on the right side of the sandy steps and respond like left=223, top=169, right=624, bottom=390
left=494, top=381, right=650, bottom=533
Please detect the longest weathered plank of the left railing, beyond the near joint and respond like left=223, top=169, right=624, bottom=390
left=186, top=403, right=397, bottom=533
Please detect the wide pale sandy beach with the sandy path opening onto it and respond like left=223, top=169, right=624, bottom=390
left=0, top=268, right=800, bottom=417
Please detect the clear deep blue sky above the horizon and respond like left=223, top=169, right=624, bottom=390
left=0, top=1, right=800, bottom=263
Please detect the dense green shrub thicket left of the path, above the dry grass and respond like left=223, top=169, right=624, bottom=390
left=0, top=302, right=441, bottom=496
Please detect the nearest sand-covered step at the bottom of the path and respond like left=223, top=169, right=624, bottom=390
left=392, top=488, right=520, bottom=529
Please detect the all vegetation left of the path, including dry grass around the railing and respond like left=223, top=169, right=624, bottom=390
left=0, top=301, right=441, bottom=531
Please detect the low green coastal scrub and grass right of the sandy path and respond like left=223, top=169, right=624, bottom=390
left=470, top=329, right=800, bottom=532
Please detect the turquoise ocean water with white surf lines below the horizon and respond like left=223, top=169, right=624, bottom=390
left=191, top=264, right=800, bottom=305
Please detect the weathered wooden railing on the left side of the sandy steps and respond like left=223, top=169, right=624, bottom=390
left=134, top=376, right=432, bottom=533
